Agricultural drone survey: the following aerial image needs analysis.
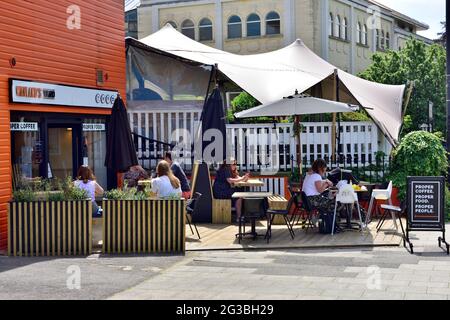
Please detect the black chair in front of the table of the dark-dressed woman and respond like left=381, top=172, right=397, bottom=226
left=236, top=198, right=270, bottom=243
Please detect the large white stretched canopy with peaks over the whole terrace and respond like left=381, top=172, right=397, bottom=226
left=132, top=24, right=405, bottom=145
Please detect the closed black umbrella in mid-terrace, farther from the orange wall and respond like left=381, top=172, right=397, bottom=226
left=201, top=88, right=227, bottom=162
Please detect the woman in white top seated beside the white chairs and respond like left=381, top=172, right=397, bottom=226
left=303, top=159, right=335, bottom=212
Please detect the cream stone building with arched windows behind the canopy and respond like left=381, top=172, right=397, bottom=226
left=133, top=0, right=432, bottom=74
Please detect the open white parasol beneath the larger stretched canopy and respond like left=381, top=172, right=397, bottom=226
left=234, top=95, right=358, bottom=118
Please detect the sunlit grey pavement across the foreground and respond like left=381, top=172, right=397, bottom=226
left=0, top=232, right=450, bottom=300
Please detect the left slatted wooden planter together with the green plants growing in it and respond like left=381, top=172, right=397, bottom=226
left=8, top=178, right=92, bottom=256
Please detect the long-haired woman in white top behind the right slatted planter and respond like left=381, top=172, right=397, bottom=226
left=152, top=161, right=181, bottom=198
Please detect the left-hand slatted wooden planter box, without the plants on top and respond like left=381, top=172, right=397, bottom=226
left=8, top=200, right=92, bottom=256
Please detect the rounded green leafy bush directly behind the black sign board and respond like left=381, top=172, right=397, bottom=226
left=389, top=131, right=448, bottom=200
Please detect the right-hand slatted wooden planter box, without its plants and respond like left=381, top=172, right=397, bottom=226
left=103, top=200, right=186, bottom=254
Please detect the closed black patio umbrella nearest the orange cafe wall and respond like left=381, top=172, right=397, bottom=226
left=105, top=95, right=139, bottom=172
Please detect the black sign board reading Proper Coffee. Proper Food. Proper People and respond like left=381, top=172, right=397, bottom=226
left=407, top=177, right=445, bottom=231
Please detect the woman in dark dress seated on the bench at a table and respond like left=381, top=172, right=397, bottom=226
left=213, top=159, right=250, bottom=222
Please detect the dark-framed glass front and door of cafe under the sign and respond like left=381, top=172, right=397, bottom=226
left=10, top=112, right=108, bottom=187
